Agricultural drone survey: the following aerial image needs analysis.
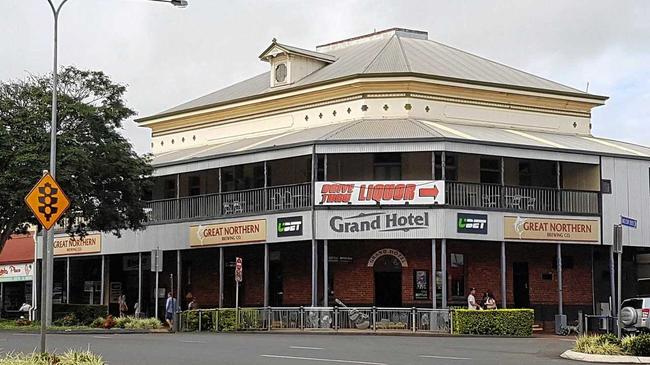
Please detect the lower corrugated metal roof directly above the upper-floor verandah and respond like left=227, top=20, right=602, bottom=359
left=152, top=119, right=650, bottom=166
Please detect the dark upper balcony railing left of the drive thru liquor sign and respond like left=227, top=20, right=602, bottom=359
left=146, top=183, right=312, bottom=223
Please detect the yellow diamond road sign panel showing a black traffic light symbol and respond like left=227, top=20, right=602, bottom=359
left=25, top=174, right=70, bottom=229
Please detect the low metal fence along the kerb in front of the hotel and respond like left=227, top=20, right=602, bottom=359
left=178, top=307, right=452, bottom=333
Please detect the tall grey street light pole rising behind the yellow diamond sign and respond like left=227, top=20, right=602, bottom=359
left=41, top=0, right=187, bottom=353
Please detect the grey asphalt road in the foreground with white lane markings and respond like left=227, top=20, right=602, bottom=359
left=0, top=332, right=588, bottom=365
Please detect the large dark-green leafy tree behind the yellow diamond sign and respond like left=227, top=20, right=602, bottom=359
left=0, top=67, right=152, bottom=250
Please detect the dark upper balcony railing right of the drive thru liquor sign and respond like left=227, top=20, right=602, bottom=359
left=445, top=181, right=599, bottom=214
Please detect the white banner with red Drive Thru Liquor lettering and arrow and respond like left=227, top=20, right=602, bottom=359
left=315, top=180, right=445, bottom=205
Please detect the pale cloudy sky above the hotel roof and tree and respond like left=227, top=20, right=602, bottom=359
left=0, top=0, right=650, bottom=153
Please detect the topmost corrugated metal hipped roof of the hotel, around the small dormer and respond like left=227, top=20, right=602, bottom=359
left=151, top=32, right=602, bottom=119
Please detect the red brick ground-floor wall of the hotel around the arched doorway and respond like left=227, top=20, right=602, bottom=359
left=183, top=240, right=592, bottom=307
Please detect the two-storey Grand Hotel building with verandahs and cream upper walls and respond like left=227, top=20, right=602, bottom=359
left=40, top=29, right=650, bottom=330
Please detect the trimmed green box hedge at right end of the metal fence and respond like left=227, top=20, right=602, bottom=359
left=452, top=309, right=535, bottom=337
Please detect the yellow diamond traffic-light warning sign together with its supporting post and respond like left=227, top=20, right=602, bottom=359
left=25, top=171, right=70, bottom=353
